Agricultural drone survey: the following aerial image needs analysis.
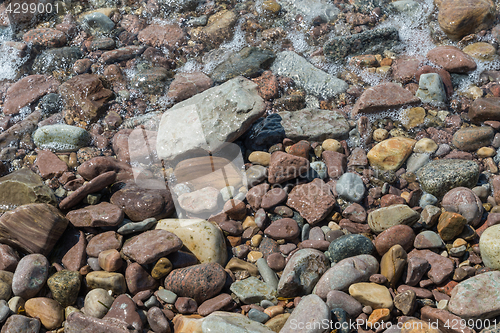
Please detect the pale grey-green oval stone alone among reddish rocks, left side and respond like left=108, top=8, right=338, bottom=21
left=33, top=124, right=90, bottom=152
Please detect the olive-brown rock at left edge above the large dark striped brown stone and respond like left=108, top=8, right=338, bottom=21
left=0, top=169, right=57, bottom=213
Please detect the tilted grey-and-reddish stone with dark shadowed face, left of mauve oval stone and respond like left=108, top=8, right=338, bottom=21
left=278, top=249, right=328, bottom=297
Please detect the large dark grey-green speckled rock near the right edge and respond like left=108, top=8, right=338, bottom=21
left=417, top=159, right=479, bottom=197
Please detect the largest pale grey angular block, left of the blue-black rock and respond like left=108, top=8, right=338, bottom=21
left=156, top=76, right=266, bottom=160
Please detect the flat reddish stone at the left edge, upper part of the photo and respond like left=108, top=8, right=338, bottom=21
left=3, top=75, right=59, bottom=115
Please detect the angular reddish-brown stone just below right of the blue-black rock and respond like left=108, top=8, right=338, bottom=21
left=268, top=151, right=309, bottom=184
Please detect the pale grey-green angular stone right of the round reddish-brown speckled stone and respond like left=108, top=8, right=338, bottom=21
left=230, top=276, right=276, bottom=304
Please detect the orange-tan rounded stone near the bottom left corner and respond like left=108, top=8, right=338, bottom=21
left=25, top=297, right=64, bottom=330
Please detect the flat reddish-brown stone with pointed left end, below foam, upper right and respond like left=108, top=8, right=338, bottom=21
left=351, top=83, right=420, bottom=117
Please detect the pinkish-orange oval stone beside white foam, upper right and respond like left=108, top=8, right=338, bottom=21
left=427, top=45, right=477, bottom=73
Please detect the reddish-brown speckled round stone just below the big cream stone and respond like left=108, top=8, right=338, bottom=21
left=165, top=263, right=226, bottom=304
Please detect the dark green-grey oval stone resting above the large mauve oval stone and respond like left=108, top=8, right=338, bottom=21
left=325, top=234, right=375, bottom=263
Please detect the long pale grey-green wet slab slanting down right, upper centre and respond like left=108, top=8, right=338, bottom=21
left=271, top=51, right=348, bottom=98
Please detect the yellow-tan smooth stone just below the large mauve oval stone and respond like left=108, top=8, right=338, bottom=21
left=349, top=282, right=393, bottom=309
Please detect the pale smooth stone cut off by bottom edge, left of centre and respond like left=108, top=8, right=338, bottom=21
left=201, top=311, right=272, bottom=333
